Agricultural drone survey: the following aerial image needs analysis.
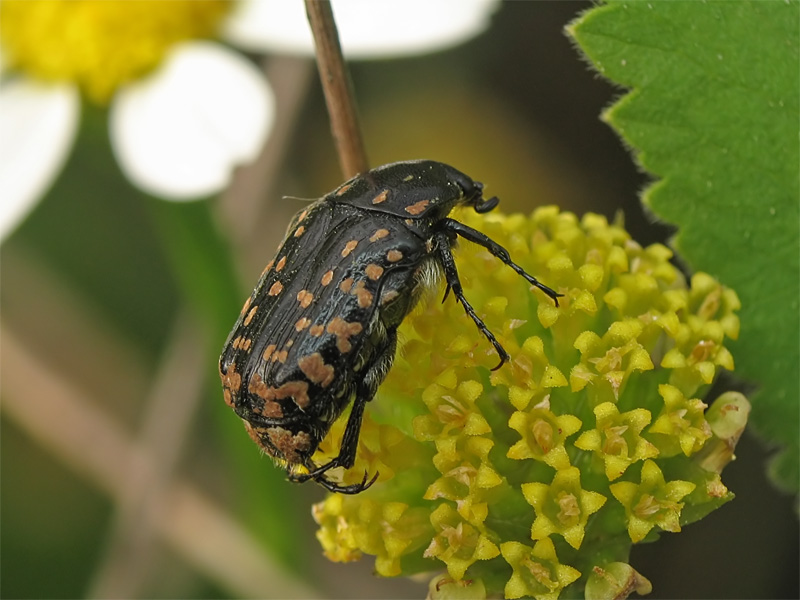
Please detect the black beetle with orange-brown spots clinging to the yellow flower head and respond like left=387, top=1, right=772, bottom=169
left=219, top=160, right=562, bottom=494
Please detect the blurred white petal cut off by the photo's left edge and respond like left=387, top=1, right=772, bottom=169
left=0, top=78, right=80, bottom=239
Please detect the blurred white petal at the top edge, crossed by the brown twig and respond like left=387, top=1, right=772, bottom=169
left=224, top=0, right=499, bottom=58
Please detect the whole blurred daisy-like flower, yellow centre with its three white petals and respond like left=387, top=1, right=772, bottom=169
left=0, top=0, right=499, bottom=240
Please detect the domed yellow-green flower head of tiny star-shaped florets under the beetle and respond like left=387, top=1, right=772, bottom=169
left=314, top=207, right=749, bottom=600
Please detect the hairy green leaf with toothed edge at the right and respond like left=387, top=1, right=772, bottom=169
left=568, top=1, right=800, bottom=490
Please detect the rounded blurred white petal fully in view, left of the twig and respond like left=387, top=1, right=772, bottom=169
left=110, top=42, right=275, bottom=200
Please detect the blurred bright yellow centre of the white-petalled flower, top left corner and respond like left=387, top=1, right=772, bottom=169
left=0, top=0, right=233, bottom=102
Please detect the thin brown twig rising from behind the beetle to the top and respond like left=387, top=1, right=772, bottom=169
left=306, top=0, right=369, bottom=179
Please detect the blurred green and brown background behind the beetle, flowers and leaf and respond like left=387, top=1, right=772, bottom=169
left=0, top=2, right=800, bottom=598
